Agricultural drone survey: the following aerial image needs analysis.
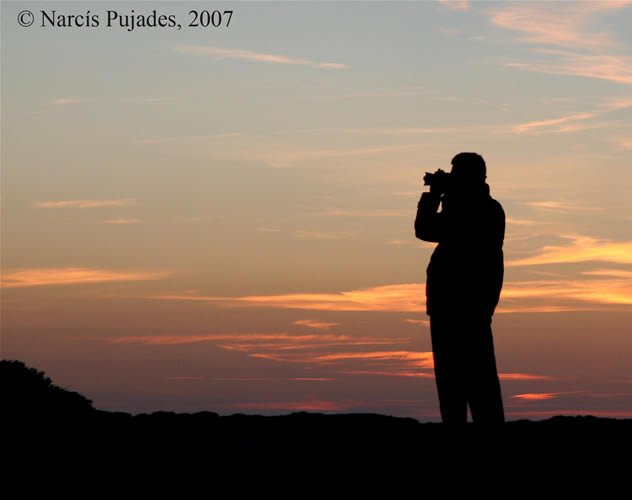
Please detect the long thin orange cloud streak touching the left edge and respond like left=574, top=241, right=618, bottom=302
left=0, top=267, right=168, bottom=288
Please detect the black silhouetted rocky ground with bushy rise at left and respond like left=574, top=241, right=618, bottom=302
left=0, top=361, right=632, bottom=488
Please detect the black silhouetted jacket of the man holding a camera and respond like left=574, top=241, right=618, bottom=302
left=415, top=183, right=505, bottom=317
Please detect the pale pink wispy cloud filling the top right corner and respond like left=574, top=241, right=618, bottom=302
left=490, top=0, right=632, bottom=84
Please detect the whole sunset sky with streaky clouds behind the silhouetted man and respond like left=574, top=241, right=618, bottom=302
left=1, top=0, right=632, bottom=420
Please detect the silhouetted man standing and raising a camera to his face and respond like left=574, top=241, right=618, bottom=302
left=415, top=153, right=505, bottom=423
